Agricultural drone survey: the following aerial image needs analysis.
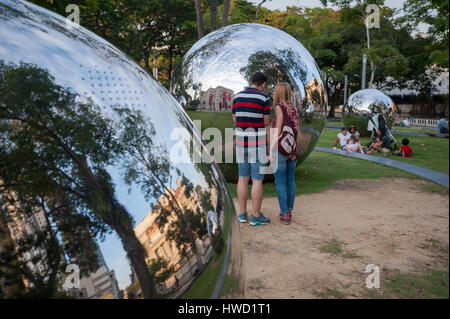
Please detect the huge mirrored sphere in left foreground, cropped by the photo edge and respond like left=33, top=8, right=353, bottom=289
left=0, top=0, right=242, bottom=298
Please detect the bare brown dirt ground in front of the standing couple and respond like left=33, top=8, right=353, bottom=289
left=235, top=178, right=449, bottom=298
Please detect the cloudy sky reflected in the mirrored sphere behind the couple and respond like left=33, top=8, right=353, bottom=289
left=183, top=23, right=320, bottom=96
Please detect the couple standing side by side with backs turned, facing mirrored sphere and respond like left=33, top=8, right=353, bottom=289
left=232, top=72, right=299, bottom=226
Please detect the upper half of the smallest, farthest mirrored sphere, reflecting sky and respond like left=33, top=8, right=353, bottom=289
left=344, top=89, right=397, bottom=117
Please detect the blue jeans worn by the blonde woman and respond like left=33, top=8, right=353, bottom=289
left=275, top=152, right=297, bottom=213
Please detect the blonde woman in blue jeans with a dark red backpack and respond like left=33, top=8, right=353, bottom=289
left=269, top=82, right=299, bottom=224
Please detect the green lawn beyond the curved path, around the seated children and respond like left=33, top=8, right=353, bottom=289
left=317, top=130, right=449, bottom=174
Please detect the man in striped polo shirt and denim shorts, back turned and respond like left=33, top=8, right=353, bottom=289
left=232, top=72, right=270, bottom=226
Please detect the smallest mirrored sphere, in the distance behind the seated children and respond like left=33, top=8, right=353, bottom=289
left=343, top=89, right=398, bottom=136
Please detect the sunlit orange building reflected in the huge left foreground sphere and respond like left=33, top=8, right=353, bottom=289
left=134, top=179, right=217, bottom=294
